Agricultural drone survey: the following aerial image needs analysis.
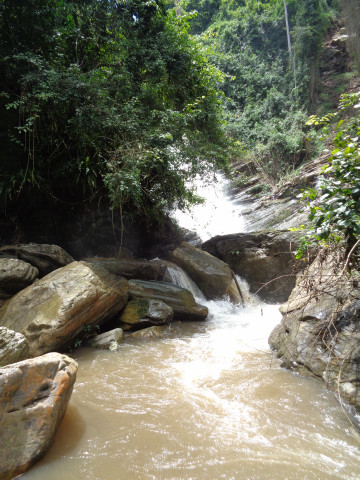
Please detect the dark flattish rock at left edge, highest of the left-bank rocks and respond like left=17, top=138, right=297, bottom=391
left=0, top=243, right=74, bottom=275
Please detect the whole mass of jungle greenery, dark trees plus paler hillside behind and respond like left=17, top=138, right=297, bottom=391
left=0, top=0, right=358, bottom=251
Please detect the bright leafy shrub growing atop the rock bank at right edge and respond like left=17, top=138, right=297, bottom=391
left=298, top=92, right=360, bottom=257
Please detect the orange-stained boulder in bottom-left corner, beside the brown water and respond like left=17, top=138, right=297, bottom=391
left=0, top=353, right=77, bottom=480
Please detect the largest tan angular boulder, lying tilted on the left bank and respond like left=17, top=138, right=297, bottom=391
left=0, top=262, right=128, bottom=356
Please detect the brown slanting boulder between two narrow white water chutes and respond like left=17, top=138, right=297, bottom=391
left=167, top=242, right=240, bottom=302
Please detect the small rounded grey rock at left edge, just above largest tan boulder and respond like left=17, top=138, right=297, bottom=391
left=0, top=257, right=39, bottom=294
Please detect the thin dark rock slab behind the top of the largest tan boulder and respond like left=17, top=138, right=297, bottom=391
left=85, top=258, right=167, bottom=280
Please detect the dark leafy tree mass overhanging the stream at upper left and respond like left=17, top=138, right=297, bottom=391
left=0, top=0, right=226, bottom=218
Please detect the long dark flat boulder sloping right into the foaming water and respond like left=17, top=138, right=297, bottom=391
left=129, top=280, right=208, bottom=320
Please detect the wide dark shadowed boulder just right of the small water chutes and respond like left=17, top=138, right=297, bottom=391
left=203, top=232, right=304, bottom=302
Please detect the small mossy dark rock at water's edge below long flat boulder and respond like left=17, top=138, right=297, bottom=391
left=120, top=298, right=174, bottom=327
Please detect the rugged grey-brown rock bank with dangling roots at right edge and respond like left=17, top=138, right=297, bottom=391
left=269, top=254, right=360, bottom=409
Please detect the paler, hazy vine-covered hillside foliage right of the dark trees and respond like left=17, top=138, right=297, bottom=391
left=184, top=0, right=330, bottom=182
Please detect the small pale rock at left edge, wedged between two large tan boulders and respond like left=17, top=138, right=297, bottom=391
left=0, top=327, right=29, bottom=367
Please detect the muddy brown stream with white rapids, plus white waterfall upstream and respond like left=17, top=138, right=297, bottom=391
left=21, top=178, right=360, bottom=480
